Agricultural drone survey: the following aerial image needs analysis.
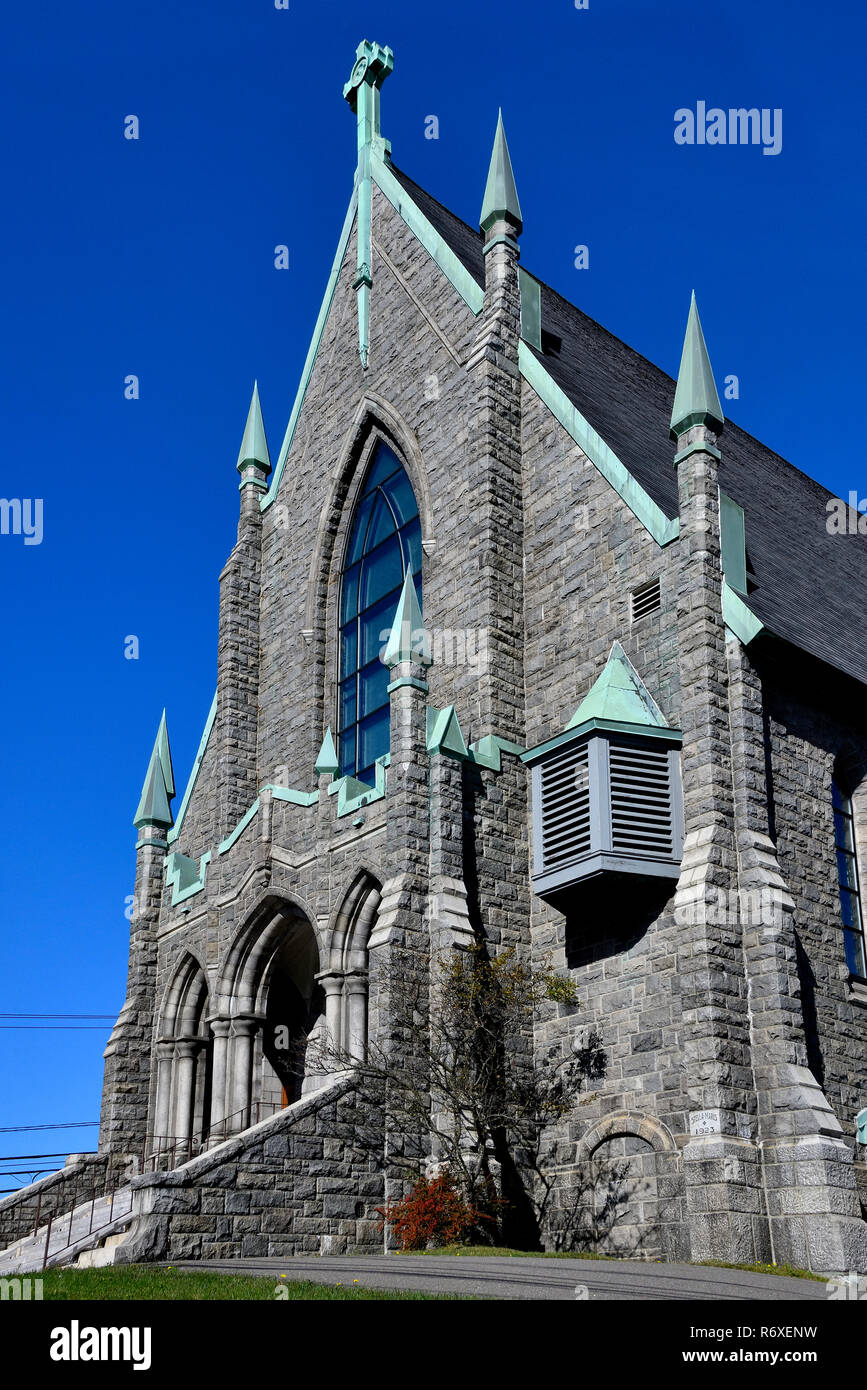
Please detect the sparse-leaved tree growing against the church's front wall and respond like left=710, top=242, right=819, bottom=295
left=294, top=948, right=606, bottom=1248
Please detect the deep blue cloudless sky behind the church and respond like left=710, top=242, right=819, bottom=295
left=0, top=0, right=867, bottom=1187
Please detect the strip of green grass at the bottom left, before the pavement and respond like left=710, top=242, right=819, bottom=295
left=42, top=1265, right=464, bottom=1302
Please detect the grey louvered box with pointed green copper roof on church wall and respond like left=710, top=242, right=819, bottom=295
left=524, top=642, right=684, bottom=902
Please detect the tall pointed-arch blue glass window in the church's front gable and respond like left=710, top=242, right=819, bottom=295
left=338, top=443, right=421, bottom=785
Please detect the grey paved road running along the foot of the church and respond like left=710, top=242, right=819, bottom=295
left=175, top=1255, right=827, bottom=1302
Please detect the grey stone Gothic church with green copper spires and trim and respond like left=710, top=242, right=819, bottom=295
left=86, top=42, right=867, bottom=1270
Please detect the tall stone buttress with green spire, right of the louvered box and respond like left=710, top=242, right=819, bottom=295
left=671, top=299, right=771, bottom=1262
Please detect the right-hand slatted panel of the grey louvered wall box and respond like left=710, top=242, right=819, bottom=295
left=609, top=744, right=674, bottom=855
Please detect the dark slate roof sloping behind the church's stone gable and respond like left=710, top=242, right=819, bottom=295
left=392, top=165, right=867, bottom=684
